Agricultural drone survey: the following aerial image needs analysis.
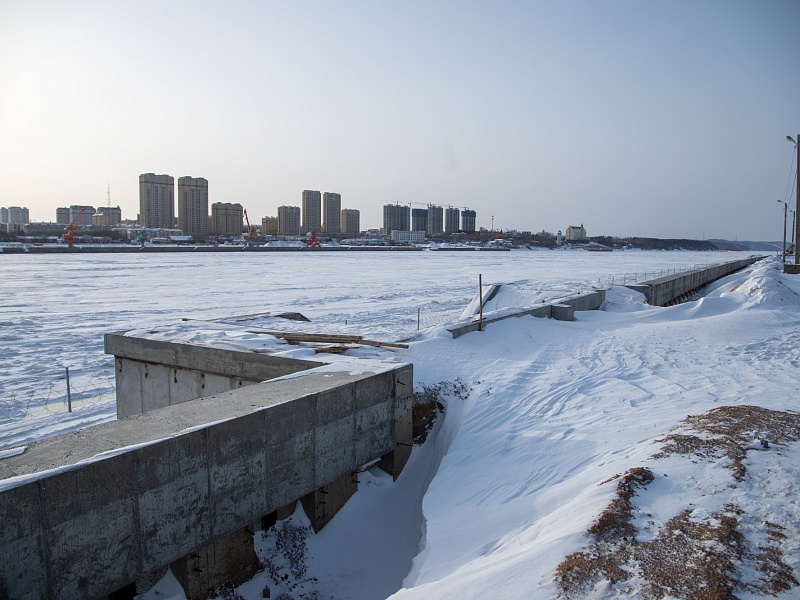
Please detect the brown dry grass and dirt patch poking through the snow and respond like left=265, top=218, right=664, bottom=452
left=556, top=406, right=800, bottom=600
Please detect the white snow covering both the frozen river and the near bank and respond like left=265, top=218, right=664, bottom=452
left=0, top=247, right=800, bottom=600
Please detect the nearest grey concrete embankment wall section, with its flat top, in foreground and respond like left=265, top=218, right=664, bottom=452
left=0, top=352, right=413, bottom=600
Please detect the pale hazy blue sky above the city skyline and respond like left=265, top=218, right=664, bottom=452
left=0, top=0, right=800, bottom=240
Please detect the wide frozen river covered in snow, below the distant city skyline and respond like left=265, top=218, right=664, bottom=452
left=0, top=250, right=764, bottom=426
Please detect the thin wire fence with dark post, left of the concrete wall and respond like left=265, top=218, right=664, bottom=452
left=0, top=367, right=116, bottom=422
